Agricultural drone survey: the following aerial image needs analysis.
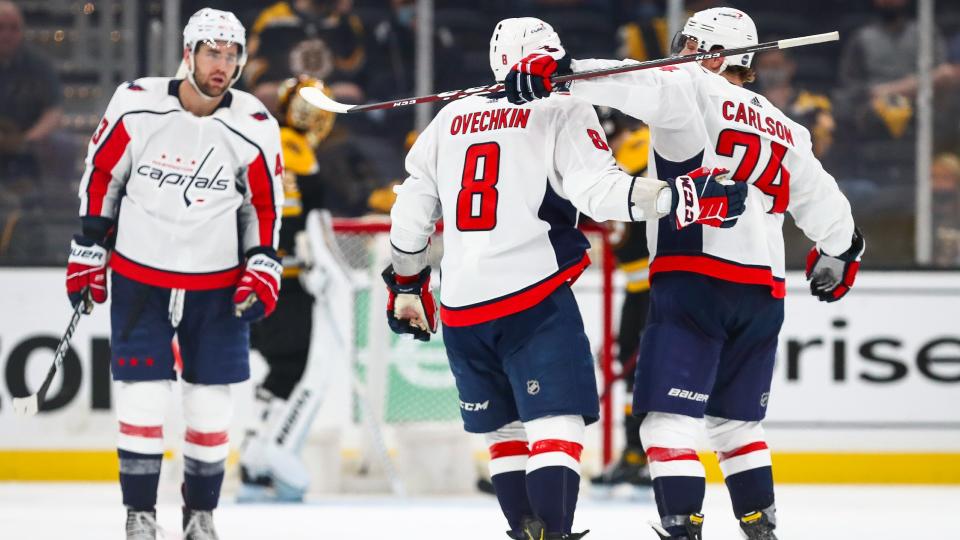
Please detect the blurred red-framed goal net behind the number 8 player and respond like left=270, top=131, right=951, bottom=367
left=317, top=218, right=614, bottom=493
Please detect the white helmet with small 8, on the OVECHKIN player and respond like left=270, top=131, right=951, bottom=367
left=490, top=17, right=564, bottom=81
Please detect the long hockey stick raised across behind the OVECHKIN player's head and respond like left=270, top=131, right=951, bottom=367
left=300, top=32, right=840, bottom=114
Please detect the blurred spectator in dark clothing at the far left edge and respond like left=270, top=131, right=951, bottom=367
left=0, top=0, right=63, bottom=202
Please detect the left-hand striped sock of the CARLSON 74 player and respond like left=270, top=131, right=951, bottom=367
left=640, top=413, right=706, bottom=536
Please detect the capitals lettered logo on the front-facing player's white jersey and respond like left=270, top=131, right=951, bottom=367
left=136, top=146, right=232, bottom=208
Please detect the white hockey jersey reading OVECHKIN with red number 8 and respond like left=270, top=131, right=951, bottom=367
left=390, top=93, right=663, bottom=326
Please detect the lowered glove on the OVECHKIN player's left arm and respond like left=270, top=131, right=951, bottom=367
left=382, top=265, right=440, bottom=341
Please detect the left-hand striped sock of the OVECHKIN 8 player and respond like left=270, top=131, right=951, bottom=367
left=486, top=422, right=533, bottom=533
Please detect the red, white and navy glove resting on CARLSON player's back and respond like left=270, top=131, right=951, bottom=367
left=667, top=167, right=747, bottom=230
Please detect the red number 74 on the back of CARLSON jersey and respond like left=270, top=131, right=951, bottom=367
left=717, top=129, right=790, bottom=214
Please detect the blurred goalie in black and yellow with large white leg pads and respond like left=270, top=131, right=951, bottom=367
left=237, top=77, right=349, bottom=502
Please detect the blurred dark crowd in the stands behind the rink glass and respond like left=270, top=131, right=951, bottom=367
left=0, top=0, right=960, bottom=268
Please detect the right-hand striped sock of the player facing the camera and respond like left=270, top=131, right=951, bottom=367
left=183, top=384, right=232, bottom=510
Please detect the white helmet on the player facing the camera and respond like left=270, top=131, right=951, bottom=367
left=177, top=8, right=247, bottom=99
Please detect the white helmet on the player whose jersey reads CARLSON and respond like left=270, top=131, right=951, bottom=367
left=674, top=7, right=757, bottom=68
